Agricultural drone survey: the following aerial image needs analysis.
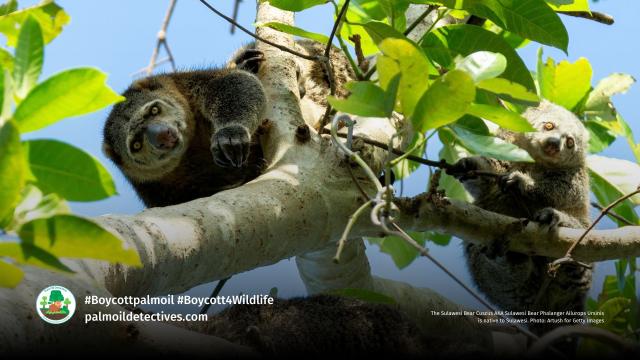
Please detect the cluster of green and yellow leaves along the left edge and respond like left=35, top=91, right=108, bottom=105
left=0, top=1, right=140, bottom=287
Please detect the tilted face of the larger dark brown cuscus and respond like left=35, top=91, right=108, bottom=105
left=103, top=84, right=192, bottom=181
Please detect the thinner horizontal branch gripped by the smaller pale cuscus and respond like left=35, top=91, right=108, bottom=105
left=396, top=195, right=640, bottom=262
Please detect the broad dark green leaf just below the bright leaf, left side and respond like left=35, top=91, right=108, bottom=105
left=24, top=140, right=116, bottom=201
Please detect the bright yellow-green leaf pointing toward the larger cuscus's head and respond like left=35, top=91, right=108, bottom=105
left=14, top=68, right=124, bottom=132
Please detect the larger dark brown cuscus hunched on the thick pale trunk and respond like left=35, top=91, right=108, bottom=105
left=103, top=51, right=266, bottom=207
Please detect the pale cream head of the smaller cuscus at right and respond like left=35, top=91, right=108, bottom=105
left=514, top=101, right=589, bottom=167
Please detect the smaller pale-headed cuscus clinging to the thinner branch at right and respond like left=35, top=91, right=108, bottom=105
left=448, top=101, right=591, bottom=344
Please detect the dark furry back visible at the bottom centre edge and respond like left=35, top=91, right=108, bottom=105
left=190, top=295, right=479, bottom=358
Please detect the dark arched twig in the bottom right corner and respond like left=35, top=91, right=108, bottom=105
left=527, top=325, right=640, bottom=359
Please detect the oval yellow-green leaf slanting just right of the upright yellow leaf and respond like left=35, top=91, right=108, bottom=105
left=411, top=70, right=476, bottom=132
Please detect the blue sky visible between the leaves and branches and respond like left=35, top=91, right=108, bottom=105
left=16, top=0, right=640, bottom=311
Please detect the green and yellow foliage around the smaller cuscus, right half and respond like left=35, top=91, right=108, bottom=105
left=260, top=0, right=640, bottom=338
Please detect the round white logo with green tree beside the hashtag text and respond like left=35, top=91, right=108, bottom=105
left=36, top=285, right=76, bottom=324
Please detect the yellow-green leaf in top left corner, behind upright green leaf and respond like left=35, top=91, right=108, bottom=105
left=0, top=1, right=71, bottom=46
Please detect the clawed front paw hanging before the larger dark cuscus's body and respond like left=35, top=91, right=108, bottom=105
left=211, top=125, right=251, bottom=168
